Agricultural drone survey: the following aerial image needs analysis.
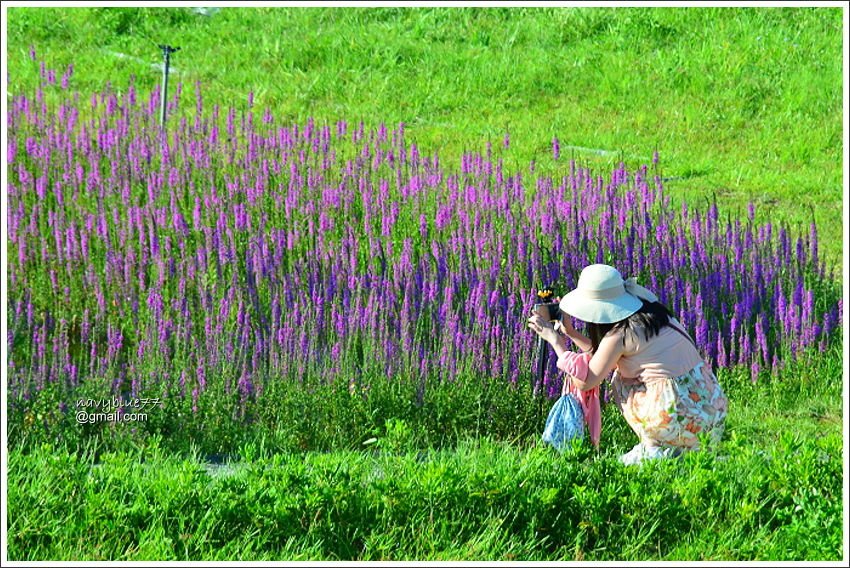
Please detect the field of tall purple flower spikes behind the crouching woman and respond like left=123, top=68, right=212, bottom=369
left=7, top=54, right=841, bottom=458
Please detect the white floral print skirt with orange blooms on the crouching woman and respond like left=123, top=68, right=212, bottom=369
left=612, top=363, right=728, bottom=450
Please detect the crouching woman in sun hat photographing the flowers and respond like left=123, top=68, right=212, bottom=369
left=528, top=264, right=727, bottom=465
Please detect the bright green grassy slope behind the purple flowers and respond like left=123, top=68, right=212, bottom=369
left=7, top=8, right=842, bottom=262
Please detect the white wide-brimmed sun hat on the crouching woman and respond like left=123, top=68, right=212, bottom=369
left=558, top=264, right=658, bottom=323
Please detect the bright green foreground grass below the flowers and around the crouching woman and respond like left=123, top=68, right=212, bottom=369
left=8, top=350, right=843, bottom=561
